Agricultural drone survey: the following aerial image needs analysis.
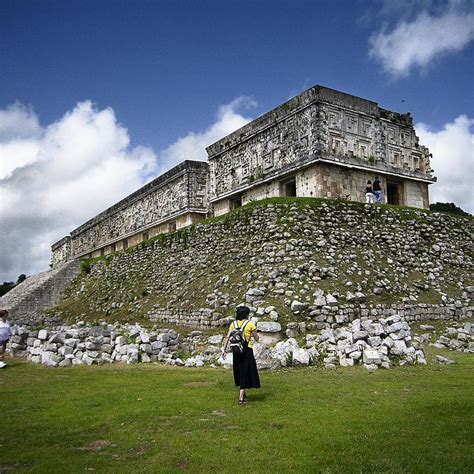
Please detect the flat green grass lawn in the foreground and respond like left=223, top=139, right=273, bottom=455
left=0, top=351, right=474, bottom=473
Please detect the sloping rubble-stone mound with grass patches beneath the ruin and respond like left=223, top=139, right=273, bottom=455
left=45, top=200, right=473, bottom=328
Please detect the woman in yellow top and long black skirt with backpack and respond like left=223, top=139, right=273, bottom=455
left=222, top=306, right=260, bottom=405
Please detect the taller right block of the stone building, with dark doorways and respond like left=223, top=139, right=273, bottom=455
left=207, top=86, right=435, bottom=215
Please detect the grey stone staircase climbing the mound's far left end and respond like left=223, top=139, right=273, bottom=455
left=0, top=260, right=80, bottom=321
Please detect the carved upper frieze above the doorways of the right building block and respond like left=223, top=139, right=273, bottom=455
left=207, top=86, right=432, bottom=200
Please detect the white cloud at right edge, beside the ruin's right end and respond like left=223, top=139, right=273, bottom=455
left=415, top=115, right=474, bottom=214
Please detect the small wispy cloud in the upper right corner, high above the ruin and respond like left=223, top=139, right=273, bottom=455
left=369, top=7, right=474, bottom=77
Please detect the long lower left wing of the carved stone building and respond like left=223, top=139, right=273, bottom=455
left=52, top=160, right=208, bottom=267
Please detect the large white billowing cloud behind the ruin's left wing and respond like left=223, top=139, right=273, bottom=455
left=0, top=97, right=253, bottom=281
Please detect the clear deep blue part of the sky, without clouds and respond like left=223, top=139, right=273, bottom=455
left=0, top=0, right=474, bottom=149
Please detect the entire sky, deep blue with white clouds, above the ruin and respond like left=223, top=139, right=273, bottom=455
left=0, top=0, right=474, bottom=280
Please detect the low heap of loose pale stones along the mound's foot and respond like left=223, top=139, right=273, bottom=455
left=6, top=315, right=434, bottom=370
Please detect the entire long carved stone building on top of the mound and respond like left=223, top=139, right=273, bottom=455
left=52, top=86, right=436, bottom=267
